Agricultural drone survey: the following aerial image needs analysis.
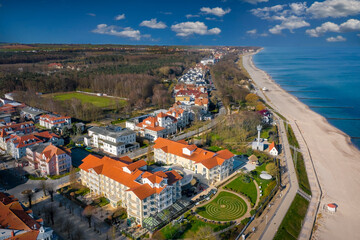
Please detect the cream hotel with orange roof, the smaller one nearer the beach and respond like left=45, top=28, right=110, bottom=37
left=154, top=138, right=234, bottom=183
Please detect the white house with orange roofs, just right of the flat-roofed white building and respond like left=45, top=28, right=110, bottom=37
left=135, top=112, right=177, bottom=141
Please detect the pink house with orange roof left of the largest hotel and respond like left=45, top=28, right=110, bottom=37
left=26, top=143, right=72, bottom=176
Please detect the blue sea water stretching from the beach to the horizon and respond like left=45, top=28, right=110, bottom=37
left=253, top=47, right=360, bottom=148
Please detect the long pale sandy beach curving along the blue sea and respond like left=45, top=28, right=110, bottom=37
left=243, top=49, right=360, bottom=239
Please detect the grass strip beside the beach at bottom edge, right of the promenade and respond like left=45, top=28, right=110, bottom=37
left=274, top=194, right=309, bottom=240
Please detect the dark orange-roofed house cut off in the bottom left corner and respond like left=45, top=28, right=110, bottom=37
left=0, top=192, right=55, bottom=240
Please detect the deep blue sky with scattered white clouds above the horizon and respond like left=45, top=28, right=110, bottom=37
left=0, top=0, right=360, bottom=47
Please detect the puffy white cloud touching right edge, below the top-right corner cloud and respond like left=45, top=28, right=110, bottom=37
left=306, top=19, right=360, bottom=37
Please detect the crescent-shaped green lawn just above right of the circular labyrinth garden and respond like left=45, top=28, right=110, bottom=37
left=224, top=175, right=257, bottom=206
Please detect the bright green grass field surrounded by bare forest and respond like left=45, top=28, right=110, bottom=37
left=52, top=92, right=126, bottom=108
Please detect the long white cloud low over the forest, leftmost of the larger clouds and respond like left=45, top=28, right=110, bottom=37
left=92, top=24, right=144, bottom=40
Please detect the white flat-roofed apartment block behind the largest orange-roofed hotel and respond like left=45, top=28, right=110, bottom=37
left=84, top=125, right=140, bottom=156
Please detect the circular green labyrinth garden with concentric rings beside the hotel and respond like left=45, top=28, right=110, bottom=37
left=196, top=192, right=247, bottom=221
